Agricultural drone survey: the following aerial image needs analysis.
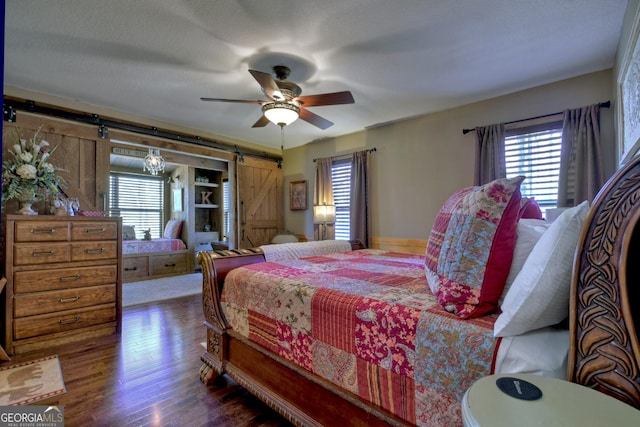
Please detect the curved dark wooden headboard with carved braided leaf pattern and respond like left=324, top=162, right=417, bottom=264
left=568, top=156, right=640, bottom=409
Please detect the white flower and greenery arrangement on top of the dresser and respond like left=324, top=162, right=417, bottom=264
left=2, top=129, right=64, bottom=207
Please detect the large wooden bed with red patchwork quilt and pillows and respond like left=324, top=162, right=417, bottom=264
left=198, top=155, right=640, bottom=425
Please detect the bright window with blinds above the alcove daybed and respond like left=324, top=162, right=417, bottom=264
left=109, top=172, right=164, bottom=239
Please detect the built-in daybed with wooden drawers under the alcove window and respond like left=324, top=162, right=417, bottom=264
left=122, top=220, right=190, bottom=283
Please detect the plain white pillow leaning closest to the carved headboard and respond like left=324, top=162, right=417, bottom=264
left=493, top=201, right=589, bottom=337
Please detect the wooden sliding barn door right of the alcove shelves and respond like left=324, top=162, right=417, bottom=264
left=237, top=158, right=284, bottom=249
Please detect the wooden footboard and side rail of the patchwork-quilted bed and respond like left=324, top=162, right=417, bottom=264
left=198, top=241, right=408, bottom=426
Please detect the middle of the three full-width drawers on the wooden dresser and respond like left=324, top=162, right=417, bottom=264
left=13, top=284, right=116, bottom=318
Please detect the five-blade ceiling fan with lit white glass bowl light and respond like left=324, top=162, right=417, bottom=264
left=200, top=65, right=354, bottom=130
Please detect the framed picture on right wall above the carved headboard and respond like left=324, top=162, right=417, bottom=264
left=617, top=4, right=640, bottom=164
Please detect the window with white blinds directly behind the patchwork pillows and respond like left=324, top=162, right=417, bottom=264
left=505, top=121, right=562, bottom=211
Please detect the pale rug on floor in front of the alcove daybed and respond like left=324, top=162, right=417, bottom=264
left=122, top=273, right=202, bottom=307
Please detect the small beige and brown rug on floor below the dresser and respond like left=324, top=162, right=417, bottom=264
left=0, top=355, right=67, bottom=406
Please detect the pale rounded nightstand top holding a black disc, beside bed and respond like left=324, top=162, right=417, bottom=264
left=462, top=374, right=640, bottom=427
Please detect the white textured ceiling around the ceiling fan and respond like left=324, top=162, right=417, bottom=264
left=4, top=0, right=626, bottom=148
